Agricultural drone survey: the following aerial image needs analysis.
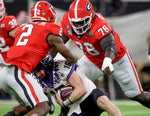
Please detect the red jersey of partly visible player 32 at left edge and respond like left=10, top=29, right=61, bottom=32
left=0, top=16, right=18, bottom=61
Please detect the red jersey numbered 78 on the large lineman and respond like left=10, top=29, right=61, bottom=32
left=61, top=13, right=126, bottom=68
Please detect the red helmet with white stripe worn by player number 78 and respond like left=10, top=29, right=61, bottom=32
left=69, top=0, right=94, bottom=35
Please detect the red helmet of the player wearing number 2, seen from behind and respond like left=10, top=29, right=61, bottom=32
left=30, top=1, right=56, bottom=23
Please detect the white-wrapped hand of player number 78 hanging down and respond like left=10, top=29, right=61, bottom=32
left=102, top=57, right=114, bottom=77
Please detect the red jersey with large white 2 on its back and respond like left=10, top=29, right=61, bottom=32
left=7, top=22, right=61, bottom=73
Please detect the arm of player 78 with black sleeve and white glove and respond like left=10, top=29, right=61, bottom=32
left=100, top=33, right=117, bottom=76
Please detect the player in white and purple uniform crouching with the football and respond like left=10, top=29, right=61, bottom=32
left=32, top=56, right=122, bottom=116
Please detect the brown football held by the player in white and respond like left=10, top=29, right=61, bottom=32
left=58, top=86, right=73, bottom=101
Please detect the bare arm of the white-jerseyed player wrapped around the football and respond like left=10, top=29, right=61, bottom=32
left=55, top=71, right=87, bottom=106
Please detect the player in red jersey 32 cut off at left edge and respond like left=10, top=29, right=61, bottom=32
left=0, top=0, right=18, bottom=66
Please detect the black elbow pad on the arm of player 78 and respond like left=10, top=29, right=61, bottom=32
left=102, top=40, right=117, bottom=56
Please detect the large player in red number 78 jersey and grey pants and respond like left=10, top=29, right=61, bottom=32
left=61, top=0, right=150, bottom=108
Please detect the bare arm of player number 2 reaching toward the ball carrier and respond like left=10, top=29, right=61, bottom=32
left=48, top=34, right=78, bottom=63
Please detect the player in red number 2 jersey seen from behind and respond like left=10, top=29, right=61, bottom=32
left=0, top=1, right=77, bottom=116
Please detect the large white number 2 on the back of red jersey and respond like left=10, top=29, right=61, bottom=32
left=16, top=24, right=33, bottom=46
